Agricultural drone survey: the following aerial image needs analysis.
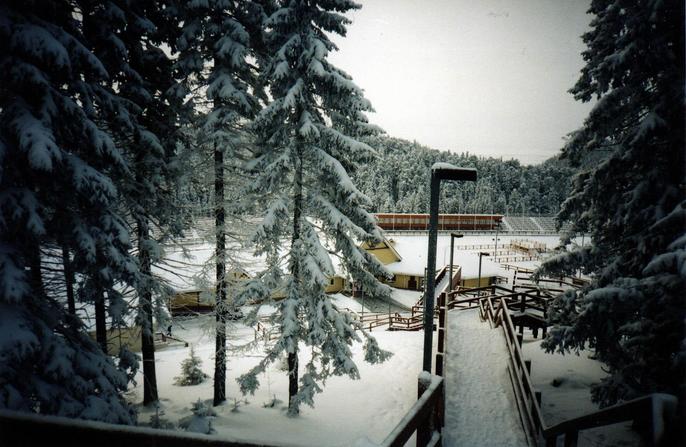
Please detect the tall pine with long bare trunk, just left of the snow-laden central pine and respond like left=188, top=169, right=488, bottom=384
left=172, top=0, right=264, bottom=405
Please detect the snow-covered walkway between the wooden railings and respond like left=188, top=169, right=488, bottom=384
left=443, top=310, right=527, bottom=447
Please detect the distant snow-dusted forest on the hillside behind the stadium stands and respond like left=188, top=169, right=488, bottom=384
left=352, top=136, right=575, bottom=215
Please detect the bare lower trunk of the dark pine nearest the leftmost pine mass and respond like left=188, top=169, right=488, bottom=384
left=137, top=217, right=159, bottom=405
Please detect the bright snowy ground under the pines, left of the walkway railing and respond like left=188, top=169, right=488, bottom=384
left=127, top=315, right=423, bottom=446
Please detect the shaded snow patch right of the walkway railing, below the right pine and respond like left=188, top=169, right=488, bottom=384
left=522, top=331, right=640, bottom=447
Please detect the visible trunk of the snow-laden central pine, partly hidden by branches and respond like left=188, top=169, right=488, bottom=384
left=288, top=146, right=303, bottom=414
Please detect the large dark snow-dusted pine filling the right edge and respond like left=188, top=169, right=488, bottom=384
left=543, top=0, right=686, bottom=406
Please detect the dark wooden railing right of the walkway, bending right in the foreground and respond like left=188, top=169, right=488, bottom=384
left=470, top=296, right=677, bottom=447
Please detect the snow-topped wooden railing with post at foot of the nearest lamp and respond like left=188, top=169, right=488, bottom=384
left=380, top=373, right=445, bottom=447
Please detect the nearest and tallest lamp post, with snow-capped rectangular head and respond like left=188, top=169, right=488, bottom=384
left=422, top=163, right=476, bottom=373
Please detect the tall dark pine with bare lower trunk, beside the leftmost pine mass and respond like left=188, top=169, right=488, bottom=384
left=85, top=0, right=195, bottom=405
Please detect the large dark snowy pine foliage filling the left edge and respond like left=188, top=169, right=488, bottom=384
left=0, top=1, right=136, bottom=423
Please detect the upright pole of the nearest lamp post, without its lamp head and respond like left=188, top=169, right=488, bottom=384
left=422, top=169, right=440, bottom=373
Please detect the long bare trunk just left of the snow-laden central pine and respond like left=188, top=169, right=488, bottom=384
left=213, top=143, right=226, bottom=405
